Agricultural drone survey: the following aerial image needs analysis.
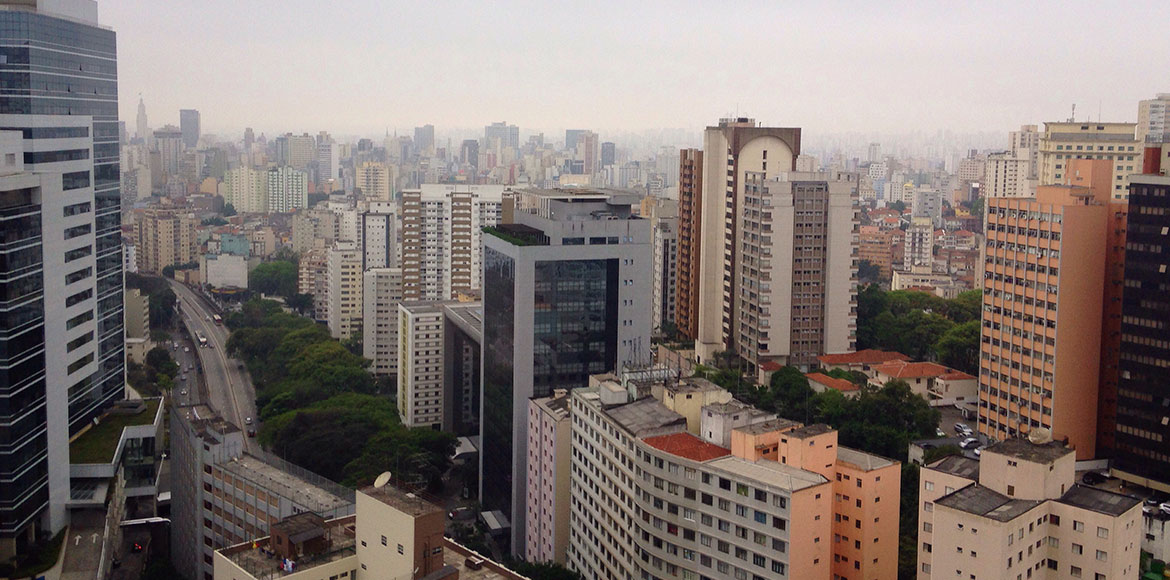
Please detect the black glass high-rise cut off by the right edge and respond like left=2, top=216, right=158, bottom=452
left=1112, top=167, right=1170, bottom=492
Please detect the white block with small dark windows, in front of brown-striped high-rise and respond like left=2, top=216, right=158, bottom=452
left=398, top=301, right=445, bottom=429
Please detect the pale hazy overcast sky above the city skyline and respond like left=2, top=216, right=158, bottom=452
left=99, top=0, right=1170, bottom=139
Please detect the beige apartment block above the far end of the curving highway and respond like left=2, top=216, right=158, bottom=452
left=135, top=208, right=199, bottom=274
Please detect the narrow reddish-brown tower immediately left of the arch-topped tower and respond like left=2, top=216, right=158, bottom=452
left=675, top=149, right=703, bottom=340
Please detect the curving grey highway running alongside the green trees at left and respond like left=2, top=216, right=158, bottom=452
left=168, top=279, right=259, bottom=450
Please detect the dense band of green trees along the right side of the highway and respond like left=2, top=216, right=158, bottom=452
left=225, top=299, right=455, bottom=488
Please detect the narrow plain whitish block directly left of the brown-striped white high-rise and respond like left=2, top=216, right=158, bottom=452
left=362, top=268, right=402, bottom=375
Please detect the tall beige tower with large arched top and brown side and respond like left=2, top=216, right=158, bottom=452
left=680, top=117, right=800, bottom=361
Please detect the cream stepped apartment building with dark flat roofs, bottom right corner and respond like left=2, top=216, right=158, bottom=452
left=918, top=433, right=1142, bottom=580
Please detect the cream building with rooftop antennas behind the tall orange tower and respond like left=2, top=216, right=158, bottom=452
left=1038, top=122, right=1143, bottom=199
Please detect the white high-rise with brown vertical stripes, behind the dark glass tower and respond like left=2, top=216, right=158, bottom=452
left=401, top=184, right=508, bottom=301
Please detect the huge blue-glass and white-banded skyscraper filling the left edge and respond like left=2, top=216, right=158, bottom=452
left=0, top=0, right=122, bottom=555
